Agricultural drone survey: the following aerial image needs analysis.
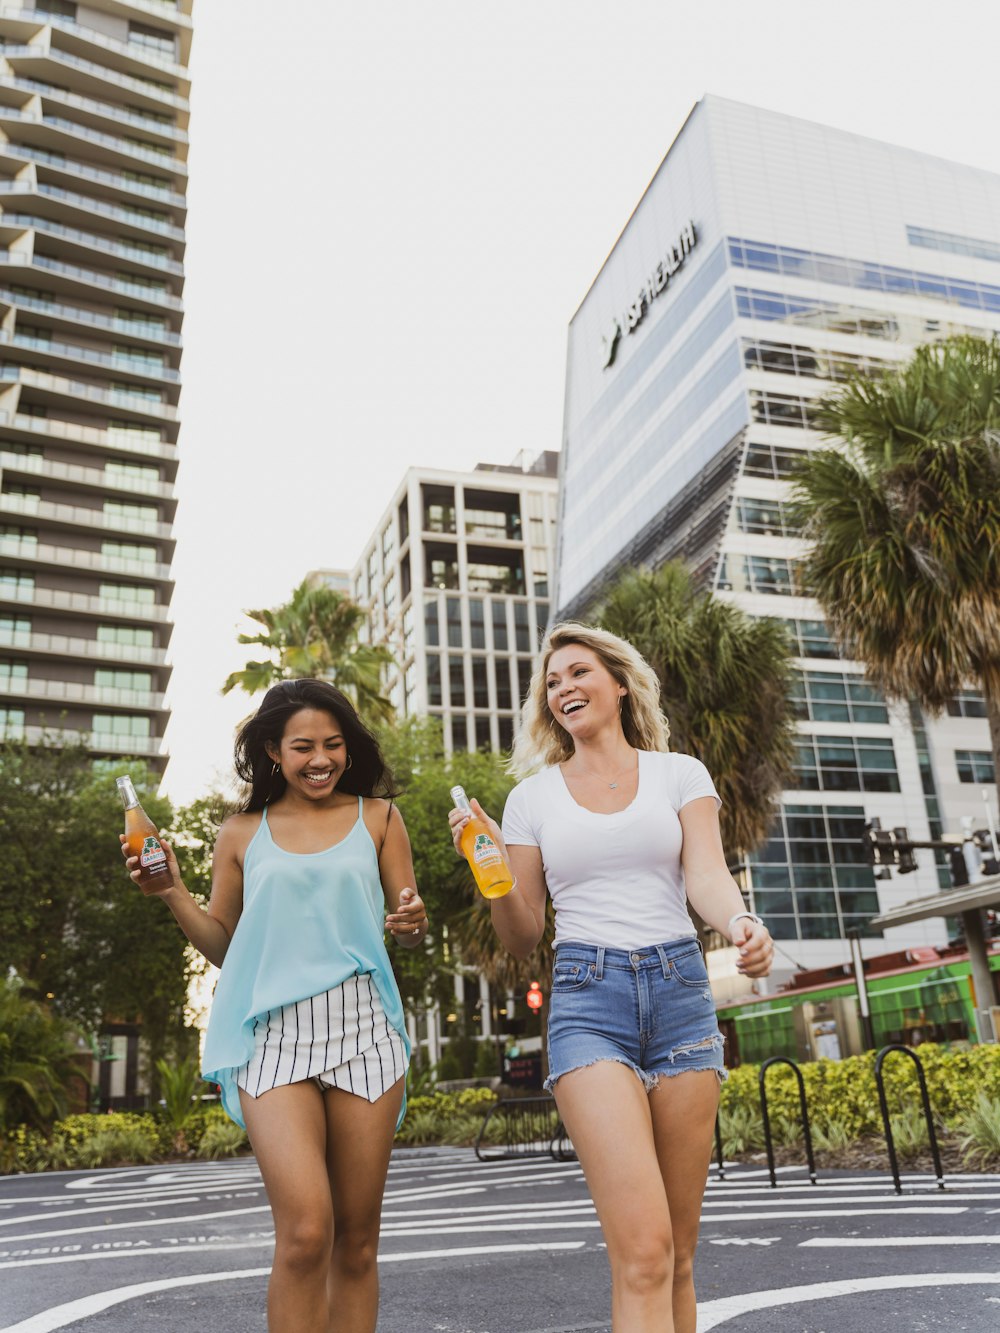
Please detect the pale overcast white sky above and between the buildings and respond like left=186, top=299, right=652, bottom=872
left=164, top=0, right=1000, bottom=802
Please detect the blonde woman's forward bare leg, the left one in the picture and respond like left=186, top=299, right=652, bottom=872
left=555, top=1060, right=675, bottom=1333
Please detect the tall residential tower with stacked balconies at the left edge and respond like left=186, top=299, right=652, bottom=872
left=0, top=0, right=192, bottom=770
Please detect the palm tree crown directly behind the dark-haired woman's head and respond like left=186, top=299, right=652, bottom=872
left=223, top=580, right=395, bottom=722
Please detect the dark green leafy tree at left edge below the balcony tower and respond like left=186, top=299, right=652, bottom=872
left=0, top=741, right=188, bottom=1058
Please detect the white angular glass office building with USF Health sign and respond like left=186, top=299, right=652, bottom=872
left=555, top=97, right=1000, bottom=966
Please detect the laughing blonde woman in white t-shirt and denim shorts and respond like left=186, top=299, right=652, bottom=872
left=449, top=624, right=773, bottom=1333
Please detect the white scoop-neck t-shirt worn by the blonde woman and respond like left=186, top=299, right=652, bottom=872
left=503, top=750, right=721, bottom=949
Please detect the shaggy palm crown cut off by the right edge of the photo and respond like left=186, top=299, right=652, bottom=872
left=795, top=336, right=1000, bottom=774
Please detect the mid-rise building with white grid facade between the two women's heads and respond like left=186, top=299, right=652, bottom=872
left=351, top=452, right=559, bottom=752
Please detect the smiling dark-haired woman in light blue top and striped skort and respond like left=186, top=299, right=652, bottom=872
left=127, top=680, right=427, bottom=1333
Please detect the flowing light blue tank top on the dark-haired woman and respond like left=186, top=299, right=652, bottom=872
left=201, top=796, right=409, bottom=1128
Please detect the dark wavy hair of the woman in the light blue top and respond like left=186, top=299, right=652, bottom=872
left=236, top=680, right=399, bottom=814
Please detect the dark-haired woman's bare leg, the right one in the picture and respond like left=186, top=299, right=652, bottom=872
left=324, top=1078, right=403, bottom=1333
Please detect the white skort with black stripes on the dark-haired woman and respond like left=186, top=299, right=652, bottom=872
left=236, top=972, right=407, bottom=1101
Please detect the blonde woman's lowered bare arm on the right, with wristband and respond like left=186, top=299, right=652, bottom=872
left=679, top=796, right=773, bottom=977
